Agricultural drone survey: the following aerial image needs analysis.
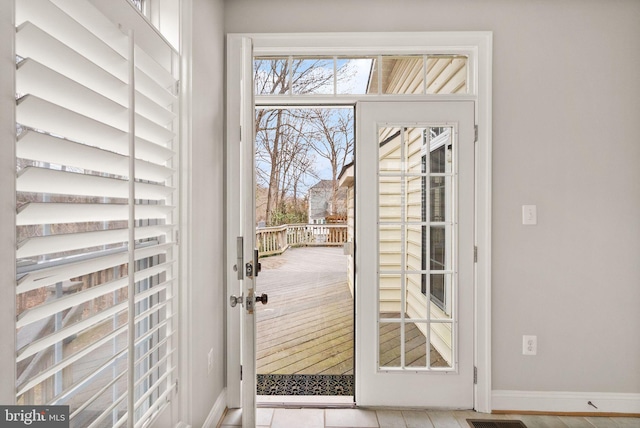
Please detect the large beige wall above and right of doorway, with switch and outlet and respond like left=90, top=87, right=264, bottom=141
left=225, top=0, right=640, bottom=393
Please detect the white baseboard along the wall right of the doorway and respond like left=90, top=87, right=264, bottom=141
left=491, top=390, right=640, bottom=414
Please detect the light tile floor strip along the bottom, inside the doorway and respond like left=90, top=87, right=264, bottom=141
left=218, top=408, right=640, bottom=428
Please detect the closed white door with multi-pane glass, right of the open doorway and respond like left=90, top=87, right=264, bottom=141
left=356, top=101, right=474, bottom=409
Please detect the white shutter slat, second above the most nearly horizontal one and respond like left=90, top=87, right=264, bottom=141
left=16, top=130, right=174, bottom=182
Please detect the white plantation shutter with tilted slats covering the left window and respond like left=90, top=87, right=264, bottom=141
left=16, top=0, right=179, bottom=427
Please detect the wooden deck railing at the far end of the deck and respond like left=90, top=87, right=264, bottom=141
left=256, top=224, right=347, bottom=257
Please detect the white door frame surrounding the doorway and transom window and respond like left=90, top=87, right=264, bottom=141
left=226, top=31, right=493, bottom=413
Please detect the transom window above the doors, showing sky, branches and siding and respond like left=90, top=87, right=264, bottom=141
left=254, top=55, right=469, bottom=97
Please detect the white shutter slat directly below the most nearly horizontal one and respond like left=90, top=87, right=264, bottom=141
left=16, top=225, right=173, bottom=259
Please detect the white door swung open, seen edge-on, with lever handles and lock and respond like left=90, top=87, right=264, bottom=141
left=226, top=37, right=266, bottom=428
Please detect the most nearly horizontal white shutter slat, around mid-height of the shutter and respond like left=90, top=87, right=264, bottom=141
left=16, top=202, right=173, bottom=226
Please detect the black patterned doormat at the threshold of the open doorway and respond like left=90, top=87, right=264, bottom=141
left=256, top=374, right=354, bottom=396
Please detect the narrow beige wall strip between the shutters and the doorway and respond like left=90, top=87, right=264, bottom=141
left=185, top=0, right=227, bottom=427
